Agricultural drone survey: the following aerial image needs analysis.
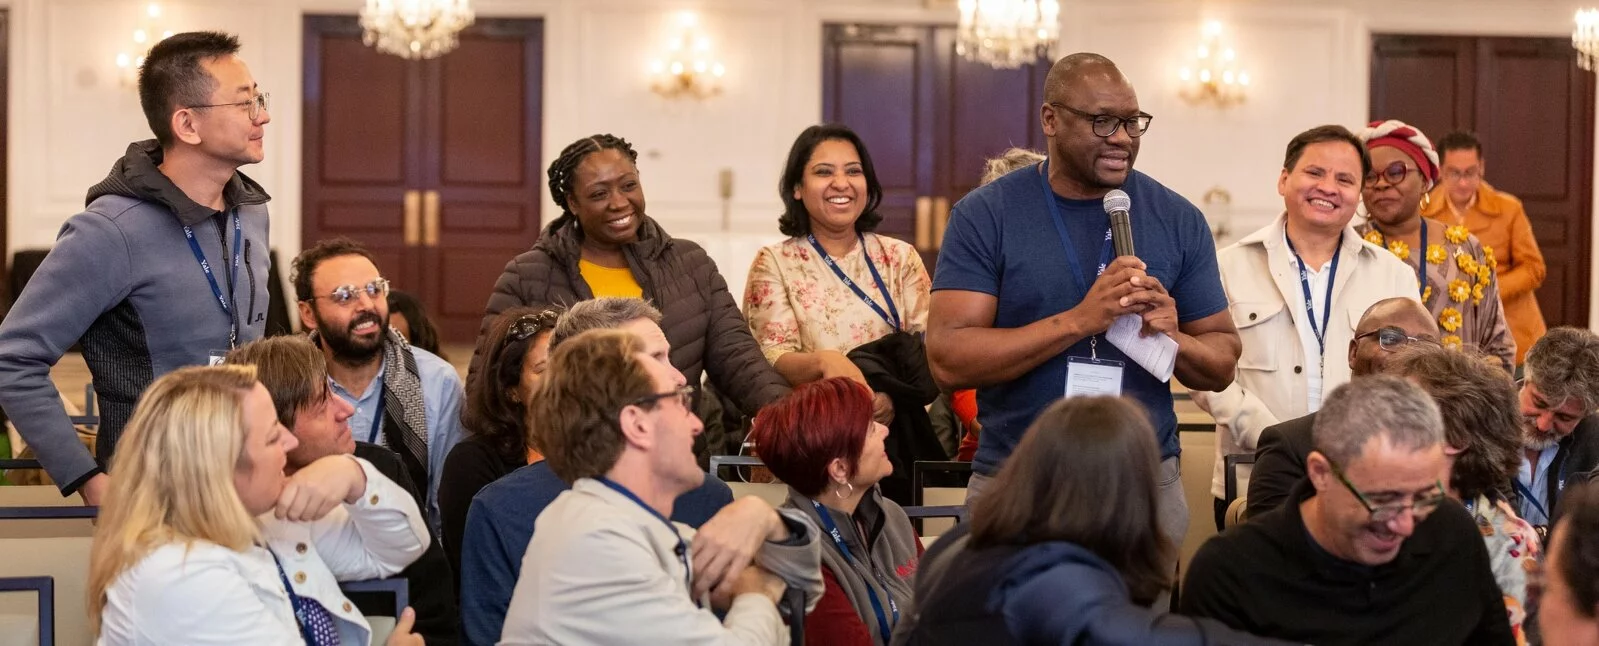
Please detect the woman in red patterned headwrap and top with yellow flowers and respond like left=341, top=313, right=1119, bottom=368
left=1356, top=120, right=1516, bottom=371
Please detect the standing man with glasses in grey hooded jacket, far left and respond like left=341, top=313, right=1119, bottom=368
left=0, top=32, right=272, bottom=505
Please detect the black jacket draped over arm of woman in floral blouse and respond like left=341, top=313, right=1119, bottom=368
left=849, top=333, right=950, bottom=505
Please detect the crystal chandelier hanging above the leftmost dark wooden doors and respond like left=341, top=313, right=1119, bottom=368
left=361, top=0, right=473, bottom=59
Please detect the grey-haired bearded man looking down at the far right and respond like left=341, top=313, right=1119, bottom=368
left=1513, top=328, right=1599, bottom=534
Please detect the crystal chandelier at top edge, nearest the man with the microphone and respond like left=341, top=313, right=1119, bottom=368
left=955, top=0, right=1060, bottom=69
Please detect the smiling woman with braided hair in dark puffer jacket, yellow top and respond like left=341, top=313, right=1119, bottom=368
left=467, top=134, right=788, bottom=438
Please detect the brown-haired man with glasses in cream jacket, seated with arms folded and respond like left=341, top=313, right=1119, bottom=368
left=500, top=329, right=822, bottom=646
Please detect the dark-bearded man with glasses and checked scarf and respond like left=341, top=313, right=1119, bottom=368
left=289, top=238, right=462, bottom=536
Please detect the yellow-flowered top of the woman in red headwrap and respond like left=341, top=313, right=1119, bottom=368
left=1356, top=219, right=1516, bottom=371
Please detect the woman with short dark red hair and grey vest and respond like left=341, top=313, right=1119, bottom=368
left=750, top=377, right=921, bottom=646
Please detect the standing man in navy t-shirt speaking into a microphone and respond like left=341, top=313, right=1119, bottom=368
left=927, top=54, right=1239, bottom=542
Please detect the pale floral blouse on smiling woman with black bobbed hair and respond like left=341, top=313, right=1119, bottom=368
left=744, top=233, right=932, bottom=363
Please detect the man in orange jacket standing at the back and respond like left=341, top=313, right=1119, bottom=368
left=1422, top=131, right=1546, bottom=366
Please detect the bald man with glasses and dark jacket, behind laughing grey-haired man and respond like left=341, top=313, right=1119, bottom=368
left=1246, top=296, right=1439, bottom=516
